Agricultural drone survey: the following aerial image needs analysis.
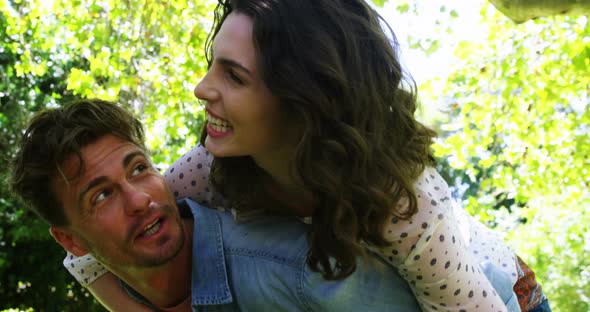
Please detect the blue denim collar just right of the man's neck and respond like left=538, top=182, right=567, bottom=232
left=183, top=199, right=233, bottom=306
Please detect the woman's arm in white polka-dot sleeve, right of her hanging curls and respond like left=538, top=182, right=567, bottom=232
left=372, top=169, right=513, bottom=311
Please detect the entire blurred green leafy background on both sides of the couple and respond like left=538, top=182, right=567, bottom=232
left=0, top=0, right=590, bottom=311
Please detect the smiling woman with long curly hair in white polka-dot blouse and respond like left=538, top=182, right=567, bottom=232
left=71, top=0, right=548, bottom=311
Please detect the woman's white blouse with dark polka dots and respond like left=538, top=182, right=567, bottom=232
left=165, top=145, right=517, bottom=312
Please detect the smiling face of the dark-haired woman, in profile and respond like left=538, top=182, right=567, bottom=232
left=195, top=12, right=294, bottom=165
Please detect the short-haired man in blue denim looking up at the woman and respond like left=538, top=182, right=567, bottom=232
left=11, top=100, right=419, bottom=311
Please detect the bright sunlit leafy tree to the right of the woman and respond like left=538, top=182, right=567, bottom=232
left=430, top=3, right=590, bottom=311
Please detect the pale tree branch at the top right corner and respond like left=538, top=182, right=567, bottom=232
left=490, top=0, right=590, bottom=23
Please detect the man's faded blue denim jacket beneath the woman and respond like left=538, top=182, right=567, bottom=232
left=127, top=199, right=520, bottom=311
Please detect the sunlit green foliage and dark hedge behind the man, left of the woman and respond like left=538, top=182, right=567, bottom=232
left=0, top=0, right=214, bottom=311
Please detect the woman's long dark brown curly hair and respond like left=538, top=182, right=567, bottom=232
left=201, top=0, right=436, bottom=279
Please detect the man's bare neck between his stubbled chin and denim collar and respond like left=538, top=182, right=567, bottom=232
left=115, top=219, right=193, bottom=308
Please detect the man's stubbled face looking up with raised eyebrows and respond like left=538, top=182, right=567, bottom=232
left=52, top=135, right=184, bottom=270
